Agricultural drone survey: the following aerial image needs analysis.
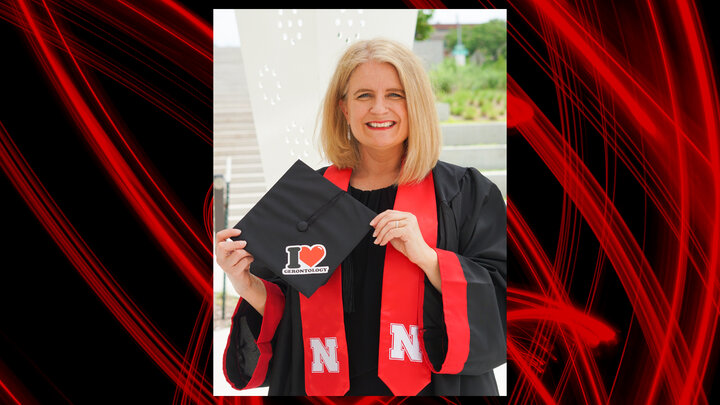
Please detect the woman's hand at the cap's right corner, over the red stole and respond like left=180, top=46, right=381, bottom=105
left=370, top=210, right=437, bottom=273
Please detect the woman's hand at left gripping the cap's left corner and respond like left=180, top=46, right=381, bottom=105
left=215, top=228, right=254, bottom=296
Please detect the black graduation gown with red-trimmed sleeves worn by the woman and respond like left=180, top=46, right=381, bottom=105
left=223, top=162, right=507, bottom=396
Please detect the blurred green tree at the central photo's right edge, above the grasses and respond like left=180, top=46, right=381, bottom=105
left=445, top=20, right=507, bottom=60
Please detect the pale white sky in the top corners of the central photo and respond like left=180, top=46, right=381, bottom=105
left=213, top=9, right=507, bottom=46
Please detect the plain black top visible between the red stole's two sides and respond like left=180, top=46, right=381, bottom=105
left=342, top=186, right=397, bottom=395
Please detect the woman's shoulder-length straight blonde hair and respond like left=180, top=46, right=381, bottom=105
left=320, top=39, right=441, bottom=184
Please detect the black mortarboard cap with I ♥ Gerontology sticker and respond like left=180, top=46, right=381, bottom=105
left=233, top=160, right=376, bottom=297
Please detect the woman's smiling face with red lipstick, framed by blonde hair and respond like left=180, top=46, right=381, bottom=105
left=340, top=61, right=408, bottom=153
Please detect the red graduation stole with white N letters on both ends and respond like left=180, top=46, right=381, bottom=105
left=300, top=166, right=437, bottom=396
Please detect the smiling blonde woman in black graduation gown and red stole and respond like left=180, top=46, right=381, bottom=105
left=216, top=40, right=507, bottom=396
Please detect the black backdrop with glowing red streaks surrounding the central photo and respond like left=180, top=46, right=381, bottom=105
left=0, top=0, right=720, bottom=404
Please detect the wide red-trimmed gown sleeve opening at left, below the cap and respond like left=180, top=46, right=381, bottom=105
left=223, top=278, right=285, bottom=390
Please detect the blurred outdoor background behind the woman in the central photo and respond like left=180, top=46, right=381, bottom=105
left=213, top=9, right=507, bottom=395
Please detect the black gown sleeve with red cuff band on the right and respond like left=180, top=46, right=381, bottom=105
left=423, top=169, right=507, bottom=375
